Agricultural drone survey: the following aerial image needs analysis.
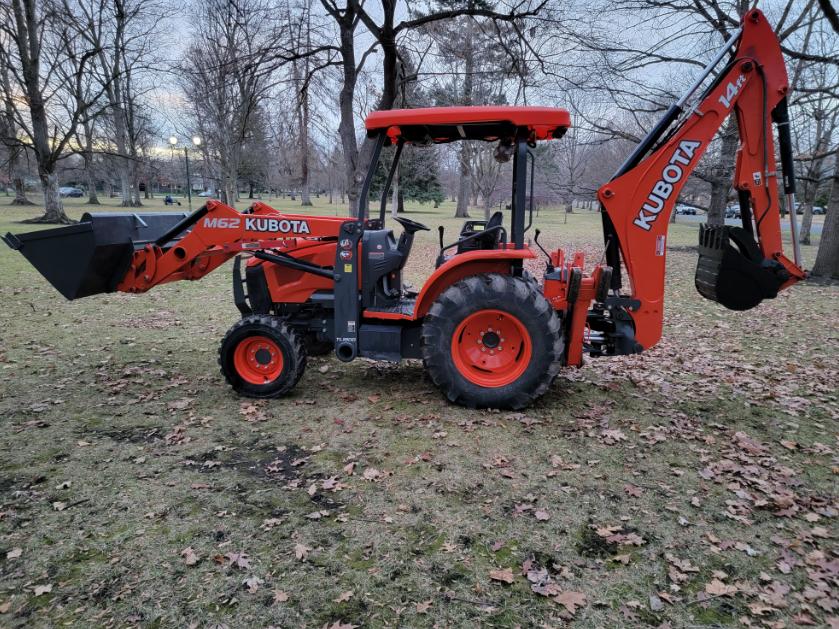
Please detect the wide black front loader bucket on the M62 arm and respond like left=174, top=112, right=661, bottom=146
left=3, top=212, right=187, bottom=299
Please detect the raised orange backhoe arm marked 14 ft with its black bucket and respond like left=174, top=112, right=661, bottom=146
left=598, top=9, right=805, bottom=349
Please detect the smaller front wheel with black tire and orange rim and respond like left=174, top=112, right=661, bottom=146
left=219, top=315, right=306, bottom=398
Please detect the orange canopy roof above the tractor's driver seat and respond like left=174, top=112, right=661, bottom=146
left=364, top=105, right=571, bottom=142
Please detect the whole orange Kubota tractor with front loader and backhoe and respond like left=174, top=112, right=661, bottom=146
left=4, top=10, right=805, bottom=409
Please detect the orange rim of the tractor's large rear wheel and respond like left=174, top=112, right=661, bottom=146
left=452, top=310, right=533, bottom=387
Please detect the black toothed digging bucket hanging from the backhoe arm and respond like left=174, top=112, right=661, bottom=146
left=696, top=225, right=789, bottom=310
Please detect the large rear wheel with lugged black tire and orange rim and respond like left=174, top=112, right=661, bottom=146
left=422, top=274, right=564, bottom=409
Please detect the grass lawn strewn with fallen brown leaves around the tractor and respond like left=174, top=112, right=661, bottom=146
left=0, top=198, right=839, bottom=628
